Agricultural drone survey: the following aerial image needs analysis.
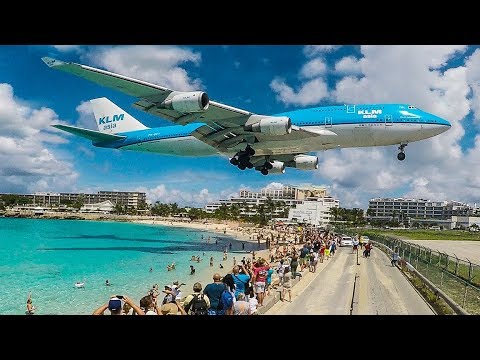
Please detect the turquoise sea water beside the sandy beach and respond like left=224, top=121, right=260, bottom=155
left=0, top=218, right=254, bottom=315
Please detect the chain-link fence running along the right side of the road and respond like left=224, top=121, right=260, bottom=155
left=365, top=233, right=480, bottom=315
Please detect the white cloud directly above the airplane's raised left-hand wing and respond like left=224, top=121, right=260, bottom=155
left=84, top=45, right=203, bottom=91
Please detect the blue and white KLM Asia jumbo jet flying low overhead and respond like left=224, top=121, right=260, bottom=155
left=42, top=57, right=451, bottom=175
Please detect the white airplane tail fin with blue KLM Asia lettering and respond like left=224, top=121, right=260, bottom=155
left=90, top=97, right=148, bottom=134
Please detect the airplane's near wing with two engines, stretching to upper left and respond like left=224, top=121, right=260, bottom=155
left=42, top=57, right=336, bottom=153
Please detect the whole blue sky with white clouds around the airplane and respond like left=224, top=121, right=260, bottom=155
left=0, top=45, right=480, bottom=208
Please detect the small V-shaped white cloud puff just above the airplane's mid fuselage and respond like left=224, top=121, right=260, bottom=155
left=270, top=78, right=328, bottom=105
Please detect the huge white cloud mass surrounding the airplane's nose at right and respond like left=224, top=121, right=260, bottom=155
left=318, top=45, right=480, bottom=208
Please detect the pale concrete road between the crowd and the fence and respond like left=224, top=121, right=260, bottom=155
left=266, top=243, right=434, bottom=315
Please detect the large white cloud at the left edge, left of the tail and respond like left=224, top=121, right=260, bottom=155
left=0, top=83, right=78, bottom=193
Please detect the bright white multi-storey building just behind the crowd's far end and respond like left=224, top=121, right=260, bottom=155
left=288, top=197, right=340, bottom=226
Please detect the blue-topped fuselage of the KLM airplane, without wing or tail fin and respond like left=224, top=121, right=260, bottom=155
left=101, top=104, right=451, bottom=156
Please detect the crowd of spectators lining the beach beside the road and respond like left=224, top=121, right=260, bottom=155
left=90, top=228, right=371, bottom=315
